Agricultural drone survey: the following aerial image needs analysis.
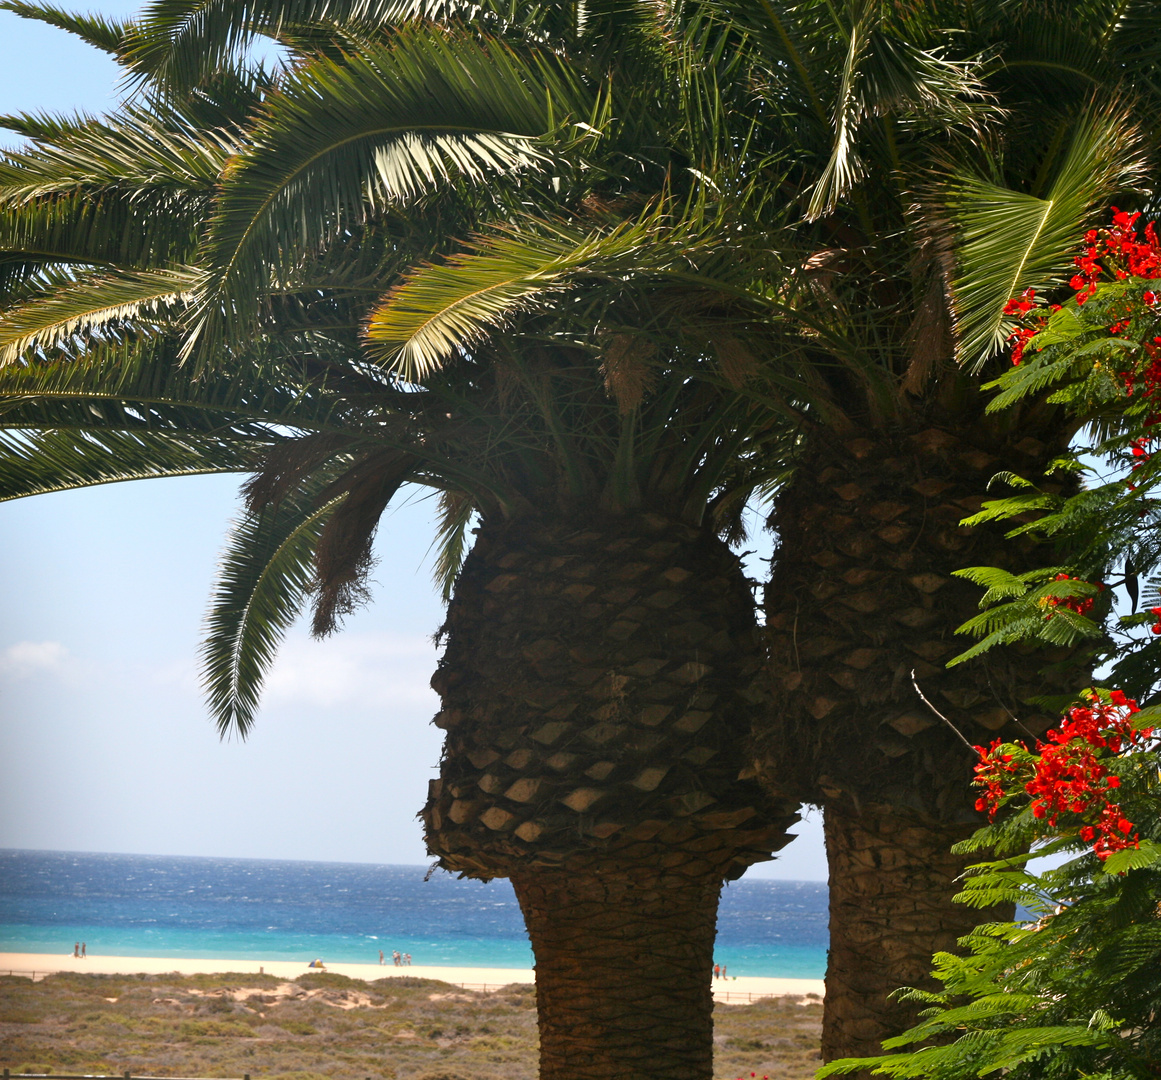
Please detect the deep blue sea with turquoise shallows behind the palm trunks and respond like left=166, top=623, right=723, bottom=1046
left=0, top=850, right=827, bottom=979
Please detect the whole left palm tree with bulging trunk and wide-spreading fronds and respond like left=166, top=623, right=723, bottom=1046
left=0, top=9, right=795, bottom=1078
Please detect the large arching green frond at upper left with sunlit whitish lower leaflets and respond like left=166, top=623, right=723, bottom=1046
left=192, top=30, right=593, bottom=362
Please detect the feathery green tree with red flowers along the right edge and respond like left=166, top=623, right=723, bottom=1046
left=820, top=207, right=1161, bottom=1080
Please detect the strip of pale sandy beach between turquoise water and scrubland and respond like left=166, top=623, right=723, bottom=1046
left=0, top=952, right=823, bottom=1001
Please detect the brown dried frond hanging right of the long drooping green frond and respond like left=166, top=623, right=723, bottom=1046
left=311, top=451, right=414, bottom=638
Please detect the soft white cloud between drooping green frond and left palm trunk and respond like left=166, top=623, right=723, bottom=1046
left=264, top=633, right=438, bottom=712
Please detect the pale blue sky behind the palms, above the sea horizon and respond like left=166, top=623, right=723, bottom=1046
left=0, top=0, right=827, bottom=880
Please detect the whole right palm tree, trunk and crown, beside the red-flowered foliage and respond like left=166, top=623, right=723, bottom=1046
left=691, top=0, right=1161, bottom=1060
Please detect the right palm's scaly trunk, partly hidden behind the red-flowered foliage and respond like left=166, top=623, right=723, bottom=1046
left=757, top=420, right=1083, bottom=1060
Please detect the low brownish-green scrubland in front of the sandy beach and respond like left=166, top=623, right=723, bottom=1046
left=0, top=973, right=822, bottom=1080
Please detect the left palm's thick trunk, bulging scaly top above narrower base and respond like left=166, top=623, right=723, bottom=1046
left=424, top=506, right=796, bottom=1080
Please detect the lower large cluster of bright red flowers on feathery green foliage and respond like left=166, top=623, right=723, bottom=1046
left=974, top=690, right=1153, bottom=862
